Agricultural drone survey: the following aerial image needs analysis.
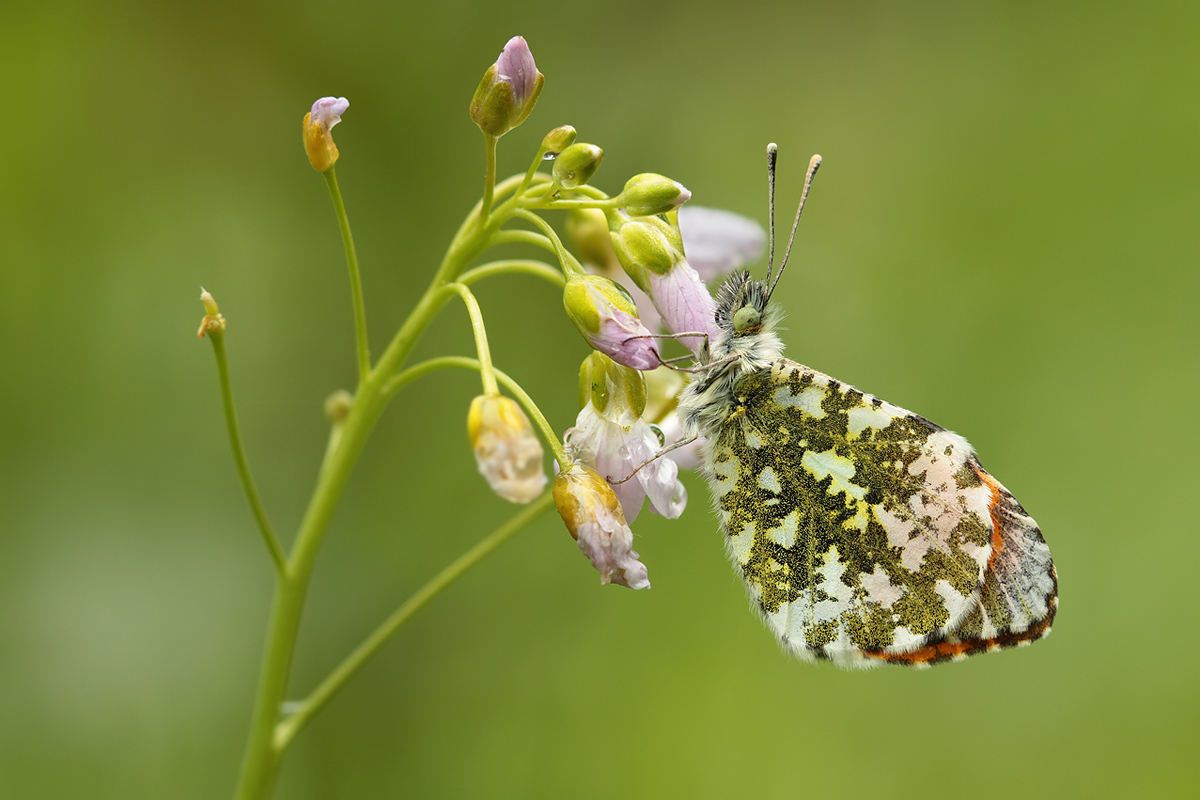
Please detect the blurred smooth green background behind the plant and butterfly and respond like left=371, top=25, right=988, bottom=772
left=0, top=1, right=1200, bottom=799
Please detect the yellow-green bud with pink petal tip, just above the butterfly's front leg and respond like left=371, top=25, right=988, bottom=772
left=563, top=275, right=662, bottom=369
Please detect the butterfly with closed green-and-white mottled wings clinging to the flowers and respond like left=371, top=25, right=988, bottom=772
left=679, top=145, right=1058, bottom=667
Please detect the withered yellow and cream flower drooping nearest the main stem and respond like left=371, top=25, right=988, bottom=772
left=467, top=395, right=547, bottom=503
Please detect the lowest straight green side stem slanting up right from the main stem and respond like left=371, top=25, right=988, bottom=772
left=275, top=492, right=553, bottom=751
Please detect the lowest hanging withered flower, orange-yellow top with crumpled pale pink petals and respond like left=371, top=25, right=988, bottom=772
left=554, top=463, right=650, bottom=589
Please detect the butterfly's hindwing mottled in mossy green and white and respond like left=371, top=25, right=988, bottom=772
left=709, top=359, right=1008, bottom=666
